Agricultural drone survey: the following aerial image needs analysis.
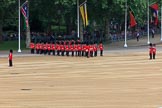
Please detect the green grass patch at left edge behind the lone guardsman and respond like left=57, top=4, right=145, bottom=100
left=0, top=40, right=27, bottom=50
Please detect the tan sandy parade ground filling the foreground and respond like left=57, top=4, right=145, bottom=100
left=0, top=35, right=162, bottom=108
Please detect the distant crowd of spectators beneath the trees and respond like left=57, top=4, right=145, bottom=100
left=3, top=28, right=158, bottom=43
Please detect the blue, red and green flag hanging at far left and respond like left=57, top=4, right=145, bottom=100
left=21, top=1, right=29, bottom=27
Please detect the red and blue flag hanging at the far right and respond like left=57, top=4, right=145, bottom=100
left=150, top=3, right=159, bottom=25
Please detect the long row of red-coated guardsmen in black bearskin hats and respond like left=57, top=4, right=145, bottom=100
left=30, top=40, right=104, bottom=58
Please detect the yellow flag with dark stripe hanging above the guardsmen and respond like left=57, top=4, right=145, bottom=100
left=79, top=1, right=88, bottom=27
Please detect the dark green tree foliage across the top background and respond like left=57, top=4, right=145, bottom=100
left=0, top=0, right=160, bottom=40
